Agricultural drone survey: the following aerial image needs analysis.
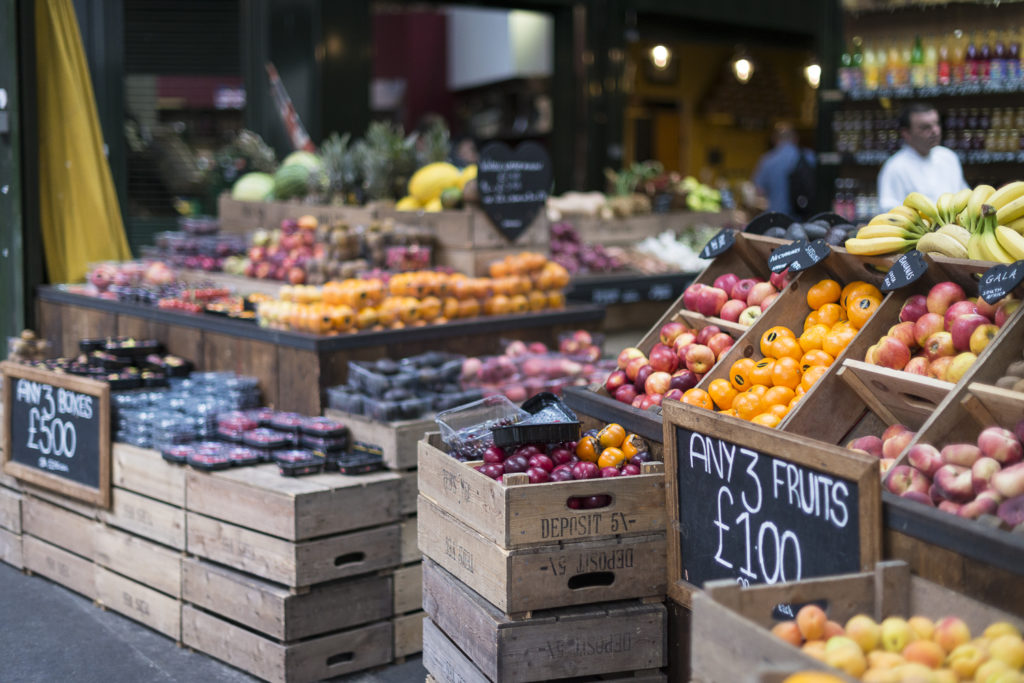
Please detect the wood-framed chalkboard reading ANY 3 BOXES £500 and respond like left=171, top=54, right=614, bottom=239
left=0, top=361, right=111, bottom=508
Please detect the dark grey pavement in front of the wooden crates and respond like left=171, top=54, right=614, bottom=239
left=0, top=562, right=427, bottom=683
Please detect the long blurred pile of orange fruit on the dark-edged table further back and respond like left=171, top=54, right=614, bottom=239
left=258, top=252, right=569, bottom=334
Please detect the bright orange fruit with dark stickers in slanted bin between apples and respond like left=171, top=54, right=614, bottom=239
left=682, top=280, right=882, bottom=427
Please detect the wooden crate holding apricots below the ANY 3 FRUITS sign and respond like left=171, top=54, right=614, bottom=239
left=691, top=562, right=1024, bottom=683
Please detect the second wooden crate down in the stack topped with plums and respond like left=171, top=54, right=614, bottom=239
left=419, top=496, right=666, bottom=615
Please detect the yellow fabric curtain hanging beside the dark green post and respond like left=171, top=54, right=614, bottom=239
left=35, top=0, right=131, bottom=283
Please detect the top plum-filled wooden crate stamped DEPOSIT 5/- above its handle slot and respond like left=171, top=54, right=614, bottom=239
left=419, top=433, right=666, bottom=550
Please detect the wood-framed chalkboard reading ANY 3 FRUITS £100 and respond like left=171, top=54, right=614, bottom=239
left=662, top=401, right=882, bottom=605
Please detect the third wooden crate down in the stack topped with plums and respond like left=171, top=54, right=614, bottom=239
left=423, top=560, right=666, bottom=683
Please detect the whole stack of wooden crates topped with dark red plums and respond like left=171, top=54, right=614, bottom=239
left=419, top=433, right=666, bottom=682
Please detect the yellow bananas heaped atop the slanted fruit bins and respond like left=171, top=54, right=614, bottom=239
left=846, top=180, right=1024, bottom=263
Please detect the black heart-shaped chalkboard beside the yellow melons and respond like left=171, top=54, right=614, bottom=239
left=476, top=142, right=552, bottom=242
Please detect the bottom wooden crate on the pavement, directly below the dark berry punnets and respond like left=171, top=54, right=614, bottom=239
left=181, top=604, right=393, bottom=683
